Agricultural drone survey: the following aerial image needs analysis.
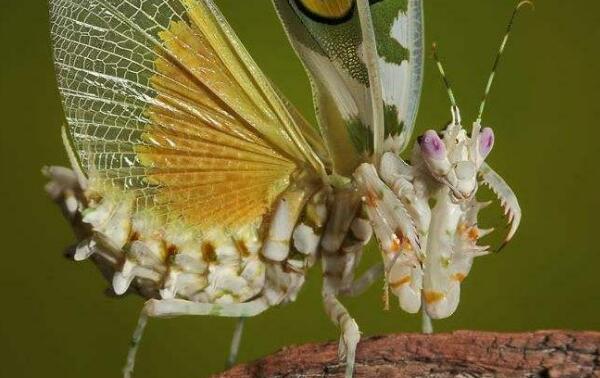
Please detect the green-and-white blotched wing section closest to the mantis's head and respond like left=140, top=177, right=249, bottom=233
left=371, top=0, right=424, bottom=153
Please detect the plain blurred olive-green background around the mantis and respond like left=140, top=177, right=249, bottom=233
left=0, top=0, right=600, bottom=378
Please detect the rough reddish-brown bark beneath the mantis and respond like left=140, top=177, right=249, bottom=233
left=217, top=331, right=600, bottom=378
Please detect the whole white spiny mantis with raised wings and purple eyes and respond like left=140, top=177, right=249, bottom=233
left=46, top=0, right=523, bottom=377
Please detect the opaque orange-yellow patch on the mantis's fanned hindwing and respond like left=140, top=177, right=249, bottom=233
left=136, top=15, right=297, bottom=228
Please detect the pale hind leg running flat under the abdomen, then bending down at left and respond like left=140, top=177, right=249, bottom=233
left=123, top=297, right=269, bottom=378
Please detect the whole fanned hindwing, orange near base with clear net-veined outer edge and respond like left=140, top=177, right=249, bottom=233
left=50, top=0, right=322, bottom=226
